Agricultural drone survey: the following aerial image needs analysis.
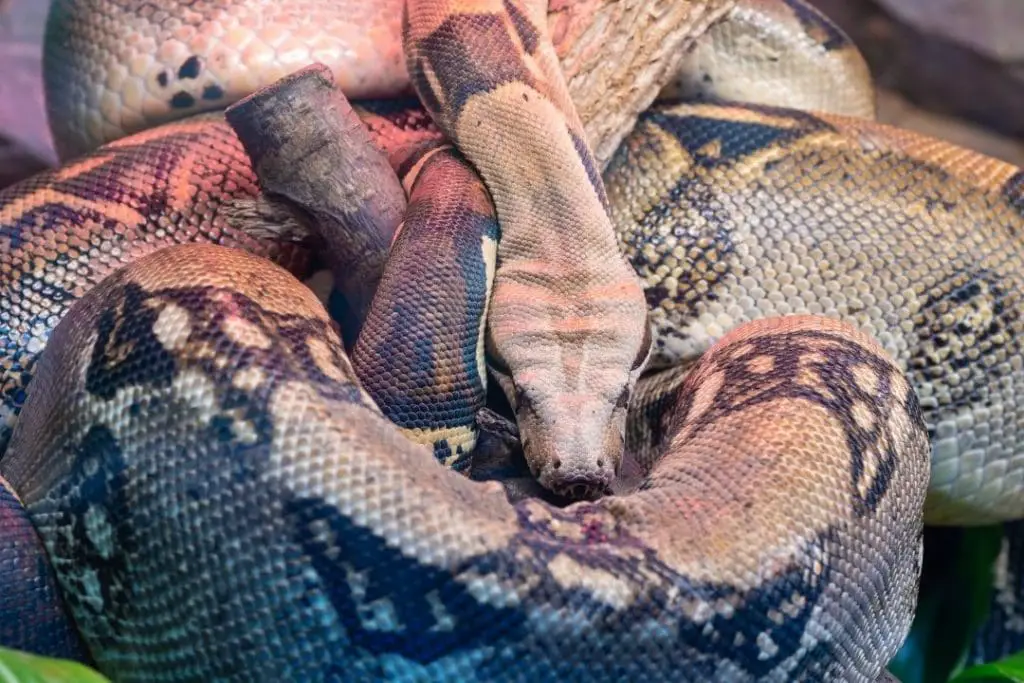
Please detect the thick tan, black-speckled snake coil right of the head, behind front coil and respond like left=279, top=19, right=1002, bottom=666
left=605, top=104, right=1024, bottom=524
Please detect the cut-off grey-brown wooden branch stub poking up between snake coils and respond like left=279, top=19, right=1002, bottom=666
left=225, top=63, right=406, bottom=339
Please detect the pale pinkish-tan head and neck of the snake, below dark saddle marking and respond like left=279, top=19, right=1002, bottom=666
left=460, top=86, right=647, bottom=497
